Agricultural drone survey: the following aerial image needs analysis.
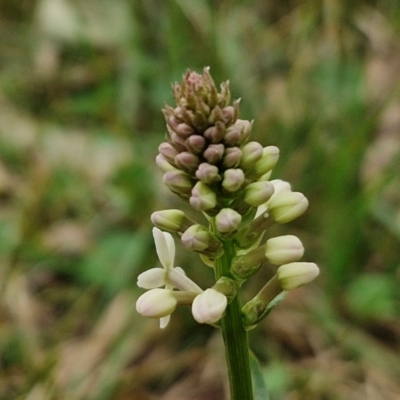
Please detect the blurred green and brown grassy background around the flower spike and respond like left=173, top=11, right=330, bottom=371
left=0, top=0, right=400, bottom=400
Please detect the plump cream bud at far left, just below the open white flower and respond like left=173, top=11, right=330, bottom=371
left=136, top=289, right=178, bottom=318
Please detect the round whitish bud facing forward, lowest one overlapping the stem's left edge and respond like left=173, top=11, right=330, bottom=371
left=192, top=289, right=228, bottom=324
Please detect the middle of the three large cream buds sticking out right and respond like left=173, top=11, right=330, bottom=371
left=265, top=235, right=304, bottom=265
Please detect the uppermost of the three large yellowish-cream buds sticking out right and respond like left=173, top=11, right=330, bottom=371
left=268, top=192, right=308, bottom=224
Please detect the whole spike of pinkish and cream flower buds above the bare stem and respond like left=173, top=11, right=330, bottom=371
left=137, top=68, right=319, bottom=326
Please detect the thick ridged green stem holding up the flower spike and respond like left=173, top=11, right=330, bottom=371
left=216, top=240, right=253, bottom=400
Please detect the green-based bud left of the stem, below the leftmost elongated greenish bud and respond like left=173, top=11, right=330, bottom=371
left=181, top=224, right=222, bottom=255
